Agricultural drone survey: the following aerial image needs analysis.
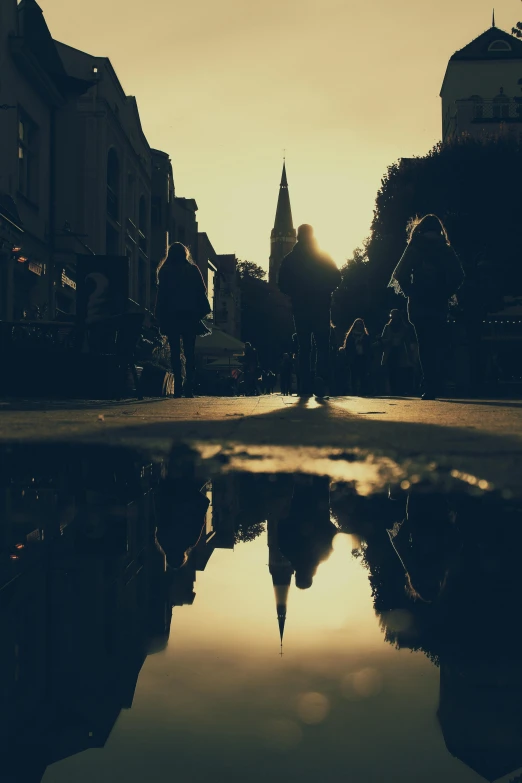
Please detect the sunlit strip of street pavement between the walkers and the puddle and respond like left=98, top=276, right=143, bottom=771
left=0, top=395, right=522, bottom=494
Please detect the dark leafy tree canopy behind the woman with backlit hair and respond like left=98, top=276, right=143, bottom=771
left=333, top=133, right=522, bottom=330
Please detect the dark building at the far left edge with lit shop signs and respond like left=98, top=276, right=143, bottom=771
left=0, top=0, right=91, bottom=320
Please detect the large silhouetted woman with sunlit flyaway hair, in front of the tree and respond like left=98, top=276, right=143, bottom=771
left=389, top=215, right=464, bottom=400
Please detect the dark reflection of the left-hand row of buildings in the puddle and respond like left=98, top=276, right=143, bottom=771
left=0, top=448, right=168, bottom=782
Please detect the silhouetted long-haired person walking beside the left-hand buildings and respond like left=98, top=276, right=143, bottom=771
left=156, top=242, right=211, bottom=397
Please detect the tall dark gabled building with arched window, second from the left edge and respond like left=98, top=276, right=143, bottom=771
left=57, top=39, right=151, bottom=308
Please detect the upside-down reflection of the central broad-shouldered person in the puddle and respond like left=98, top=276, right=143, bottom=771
left=278, top=476, right=338, bottom=590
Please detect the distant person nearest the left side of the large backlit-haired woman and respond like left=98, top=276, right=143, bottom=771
left=381, top=310, right=416, bottom=397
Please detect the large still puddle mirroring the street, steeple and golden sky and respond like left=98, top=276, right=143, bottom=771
left=0, top=447, right=522, bottom=783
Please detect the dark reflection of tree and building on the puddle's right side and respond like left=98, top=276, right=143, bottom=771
left=350, top=495, right=522, bottom=781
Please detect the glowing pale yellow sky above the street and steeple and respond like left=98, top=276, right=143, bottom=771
left=40, top=0, right=521, bottom=267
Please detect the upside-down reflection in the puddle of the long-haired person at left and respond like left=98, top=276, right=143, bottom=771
left=156, top=477, right=210, bottom=569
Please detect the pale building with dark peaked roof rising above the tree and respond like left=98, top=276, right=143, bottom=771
left=440, top=20, right=522, bottom=141
